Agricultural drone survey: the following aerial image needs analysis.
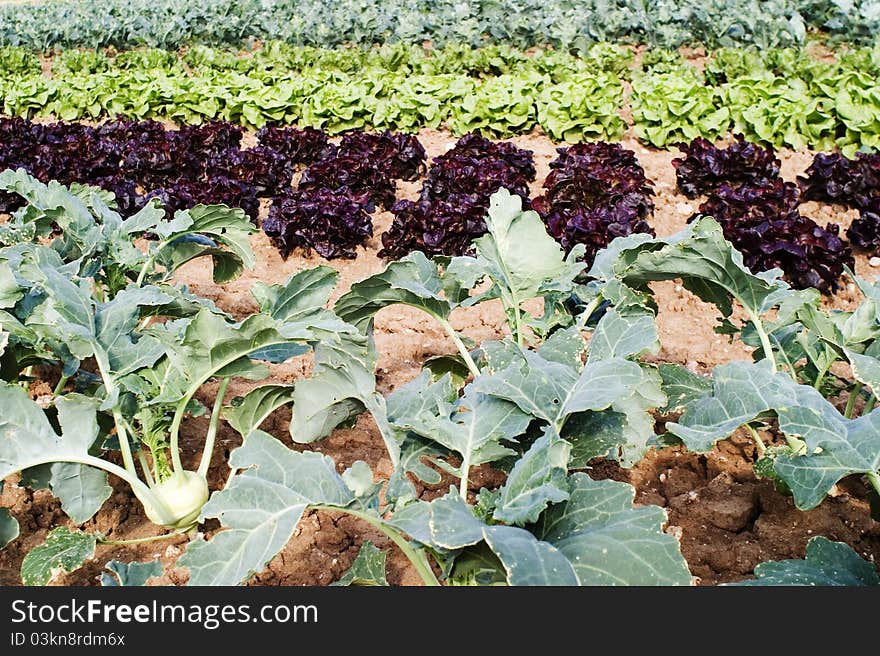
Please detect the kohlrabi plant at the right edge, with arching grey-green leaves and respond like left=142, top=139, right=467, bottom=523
left=591, top=218, right=880, bottom=515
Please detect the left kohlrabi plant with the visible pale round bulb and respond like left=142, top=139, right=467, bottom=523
left=0, top=172, right=376, bottom=580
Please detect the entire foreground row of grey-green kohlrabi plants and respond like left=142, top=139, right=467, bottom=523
left=0, top=177, right=880, bottom=585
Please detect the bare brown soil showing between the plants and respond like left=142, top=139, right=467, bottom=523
left=0, top=130, right=880, bottom=585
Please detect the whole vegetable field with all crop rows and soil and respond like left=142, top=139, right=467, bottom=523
left=0, top=0, right=880, bottom=586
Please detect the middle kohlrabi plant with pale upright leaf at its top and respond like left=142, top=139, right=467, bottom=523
left=178, top=190, right=691, bottom=585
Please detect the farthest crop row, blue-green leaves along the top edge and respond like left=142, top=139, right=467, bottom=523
left=0, top=0, right=880, bottom=50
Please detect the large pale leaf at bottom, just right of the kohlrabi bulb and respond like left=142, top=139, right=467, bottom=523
left=178, top=431, right=355, bottom=586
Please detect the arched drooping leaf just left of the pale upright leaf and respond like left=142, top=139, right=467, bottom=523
left=333, top=251, right=457, bottom=332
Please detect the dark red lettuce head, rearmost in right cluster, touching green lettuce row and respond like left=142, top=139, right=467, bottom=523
left=672, top=135, right=780, bottom=198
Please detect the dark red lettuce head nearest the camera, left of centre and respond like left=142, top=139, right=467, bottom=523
left=263, top=188, right=373, bottom=260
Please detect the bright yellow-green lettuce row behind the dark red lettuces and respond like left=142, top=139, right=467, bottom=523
left=0, top=43, right=880, bottom=155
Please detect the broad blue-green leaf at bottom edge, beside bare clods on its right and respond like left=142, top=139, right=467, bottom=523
left=537, top=474, right=691, bottom=585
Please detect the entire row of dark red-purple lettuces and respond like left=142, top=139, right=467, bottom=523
left=0, top=119, right=880, bottom=292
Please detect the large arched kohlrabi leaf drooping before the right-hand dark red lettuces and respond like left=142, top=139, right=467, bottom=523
left=614, top=218, right=791, bottom=318
